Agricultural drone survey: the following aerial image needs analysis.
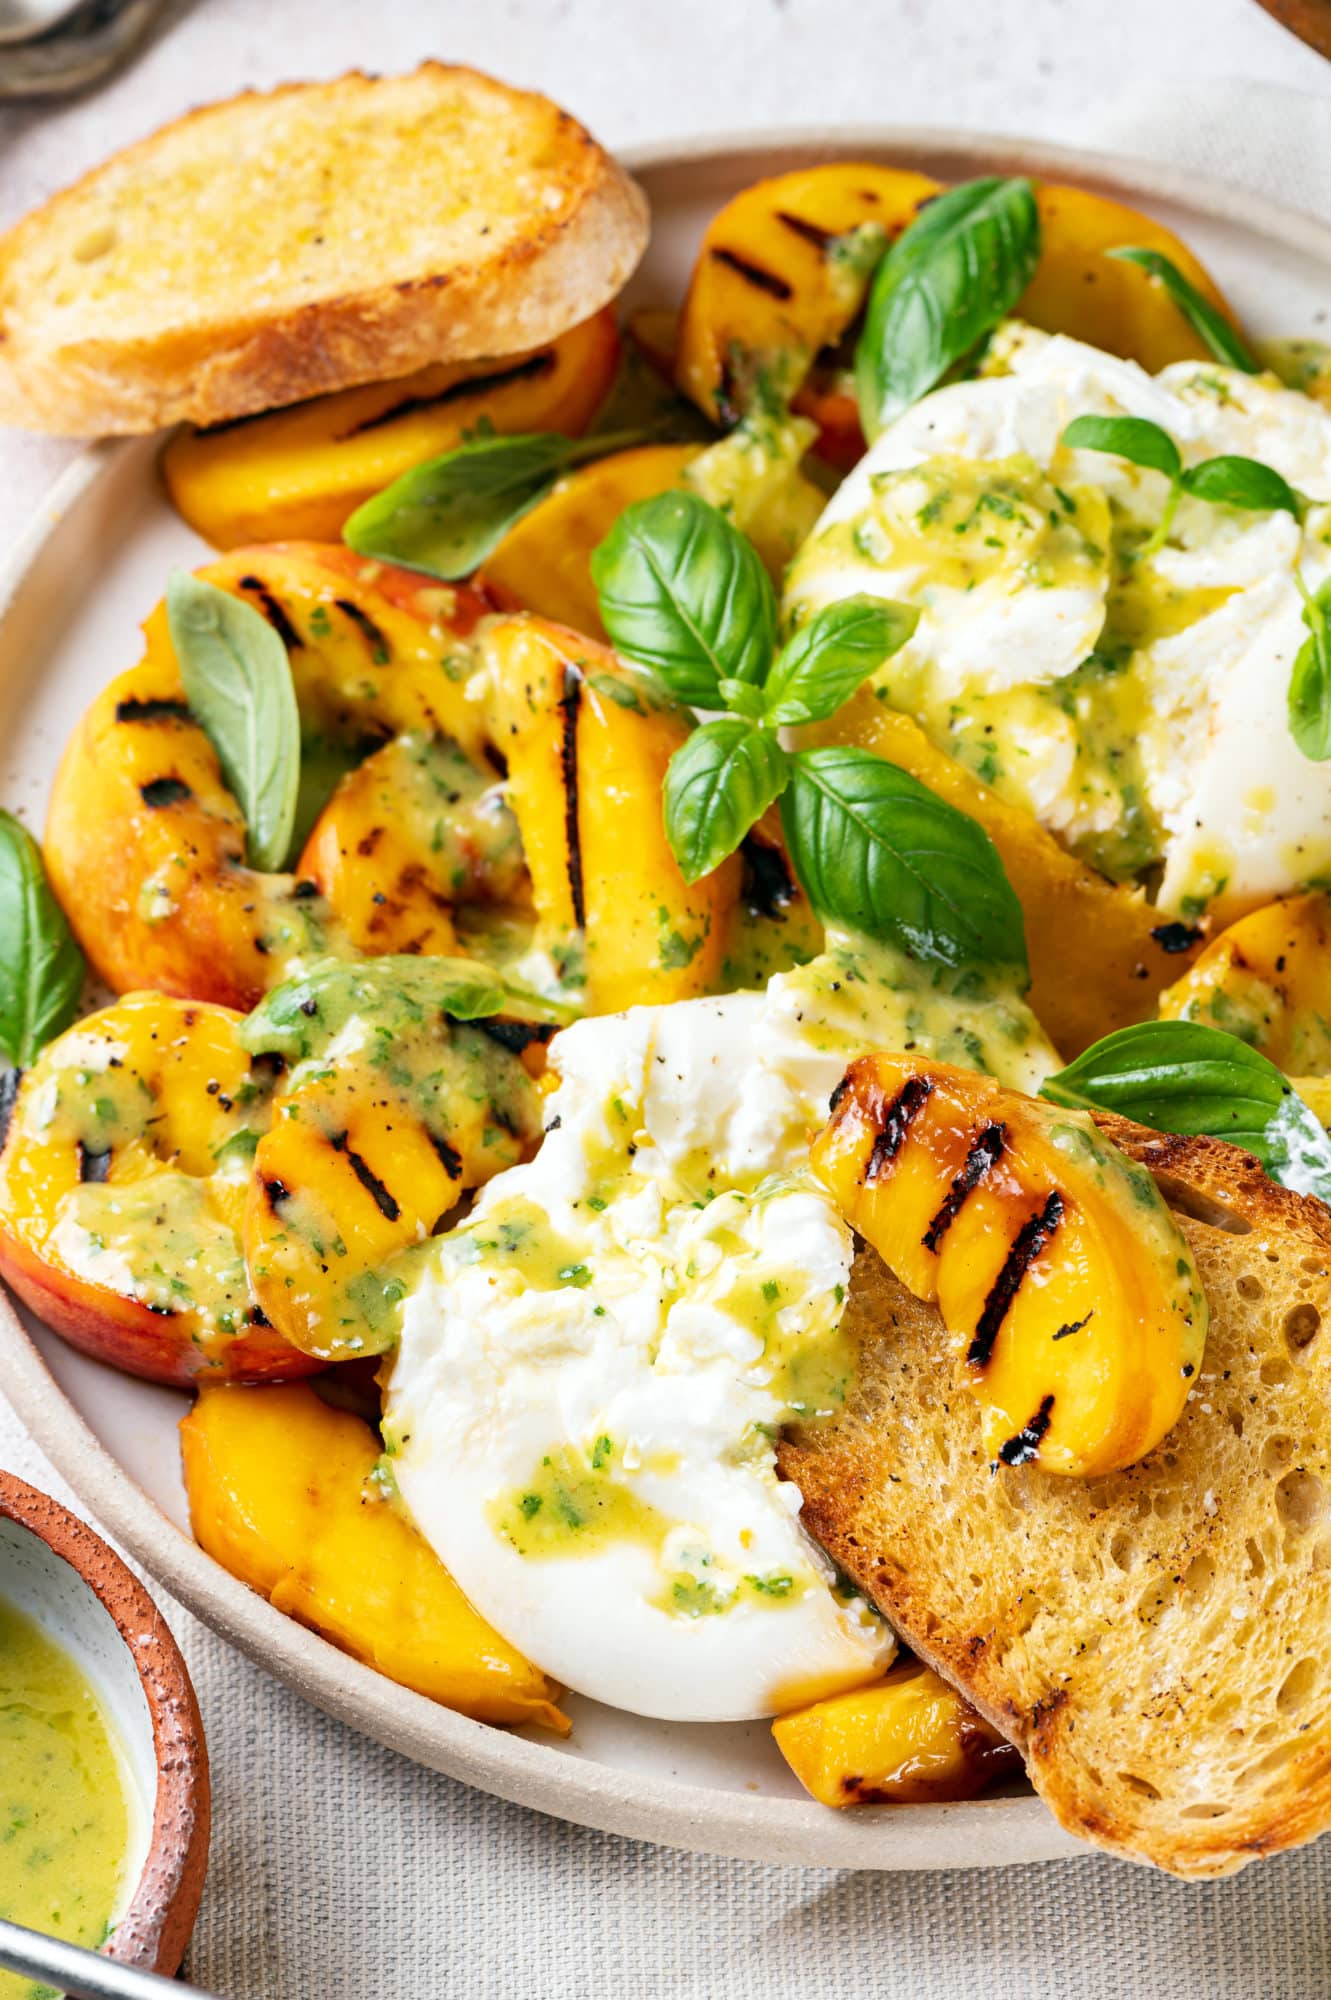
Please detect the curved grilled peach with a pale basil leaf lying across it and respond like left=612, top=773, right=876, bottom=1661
left=44, top=544, right=492, bottom=1008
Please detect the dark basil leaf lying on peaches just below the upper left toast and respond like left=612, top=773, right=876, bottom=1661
left=342, top=430, right=646, bottom=584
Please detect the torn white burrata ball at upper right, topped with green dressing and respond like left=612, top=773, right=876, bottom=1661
left=787, top=328, right=1331, bottom=920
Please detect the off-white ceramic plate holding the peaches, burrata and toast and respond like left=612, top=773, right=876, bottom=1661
left=0, top=130, right=1331, bottom=1868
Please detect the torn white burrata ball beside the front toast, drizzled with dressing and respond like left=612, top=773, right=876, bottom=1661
left=384, top=952, right=1057, bottom=1720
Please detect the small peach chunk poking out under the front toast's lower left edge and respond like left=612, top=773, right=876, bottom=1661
left=771, top=1660, right=1021, bottom=1806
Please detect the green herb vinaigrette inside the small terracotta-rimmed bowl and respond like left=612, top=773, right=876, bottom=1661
left=0, top=1598, right=132, bottom=2000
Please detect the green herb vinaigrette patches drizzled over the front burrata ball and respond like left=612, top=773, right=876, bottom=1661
left=473, top=936, right=1057, bottom=1618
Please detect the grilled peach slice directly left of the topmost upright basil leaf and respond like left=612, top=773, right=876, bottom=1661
left=675, top=160, right=939, bottom=426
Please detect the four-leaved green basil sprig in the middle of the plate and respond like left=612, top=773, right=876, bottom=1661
left=592, top=494, right=1025, bottom=974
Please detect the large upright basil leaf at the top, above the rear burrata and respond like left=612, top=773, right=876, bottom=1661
left=855, top=176, right=1039, bottom=440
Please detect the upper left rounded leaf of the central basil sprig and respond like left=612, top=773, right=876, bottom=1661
left=592, top=492, right=777, bottom=708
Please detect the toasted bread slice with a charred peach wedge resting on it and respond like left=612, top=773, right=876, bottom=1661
left=781, top=1118, right=1331, bottom=1876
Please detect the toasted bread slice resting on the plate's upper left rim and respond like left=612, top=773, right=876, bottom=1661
left=0, top=62, right=648, bottom=434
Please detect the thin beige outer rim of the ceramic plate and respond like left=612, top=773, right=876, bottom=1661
left=0, top=124, right=1331, bottom=1870
